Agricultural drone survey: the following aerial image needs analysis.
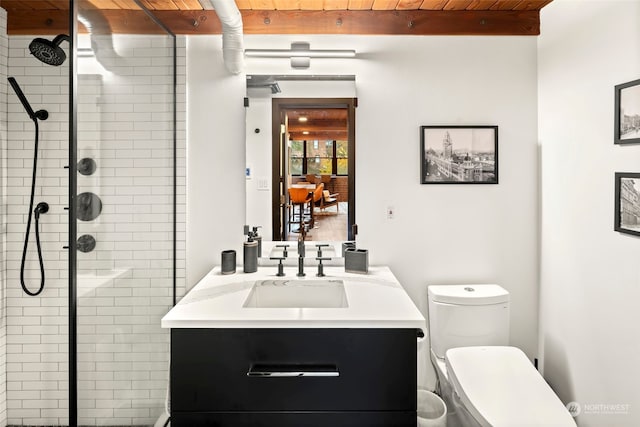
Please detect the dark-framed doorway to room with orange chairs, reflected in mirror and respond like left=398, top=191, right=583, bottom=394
left=272, top=98, right=355, bottom=241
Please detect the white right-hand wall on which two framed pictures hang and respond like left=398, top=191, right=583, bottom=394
left=538, top=0, right=640, bottom=427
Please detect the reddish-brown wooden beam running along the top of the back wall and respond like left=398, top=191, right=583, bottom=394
left=7, top=10, right=540, bottom=35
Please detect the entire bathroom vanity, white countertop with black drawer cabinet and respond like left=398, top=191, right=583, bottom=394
left=162, top=267, right=426, bottom=427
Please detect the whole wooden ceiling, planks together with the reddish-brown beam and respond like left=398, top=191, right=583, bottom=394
left=0, top=0, right=551, bottom=35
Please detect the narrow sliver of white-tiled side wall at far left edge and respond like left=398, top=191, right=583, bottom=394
left=0, top=9, right=9, bottom=427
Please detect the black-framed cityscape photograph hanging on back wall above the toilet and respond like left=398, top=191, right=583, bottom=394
left=420, top=126, right=498, bottom=184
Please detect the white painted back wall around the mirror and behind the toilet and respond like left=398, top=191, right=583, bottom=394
left=187, top=36, right=538, bottom=374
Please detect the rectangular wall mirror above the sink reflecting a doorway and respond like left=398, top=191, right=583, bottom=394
left=245, top=75, right=356, bottom=246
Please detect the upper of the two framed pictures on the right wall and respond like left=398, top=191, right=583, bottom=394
left=614, top=80, right=640, bottom=144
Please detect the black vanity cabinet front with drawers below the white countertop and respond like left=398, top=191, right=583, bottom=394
left=171, top=328, right=417, bottom=427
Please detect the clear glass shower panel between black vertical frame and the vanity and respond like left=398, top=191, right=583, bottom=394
left=75, top=1, right=175, bottom=426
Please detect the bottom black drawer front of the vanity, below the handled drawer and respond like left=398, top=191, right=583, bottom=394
left=171, top=412, right=417, bottom=427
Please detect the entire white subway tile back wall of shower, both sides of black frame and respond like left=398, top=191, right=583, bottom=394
left=5, top=31, right=186, bottom=425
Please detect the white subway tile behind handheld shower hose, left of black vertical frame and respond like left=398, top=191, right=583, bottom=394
left=5, top=37, right=69, bottom=425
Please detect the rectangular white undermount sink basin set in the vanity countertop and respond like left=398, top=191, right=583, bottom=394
left=243, top=279, right=349, bottom=308
